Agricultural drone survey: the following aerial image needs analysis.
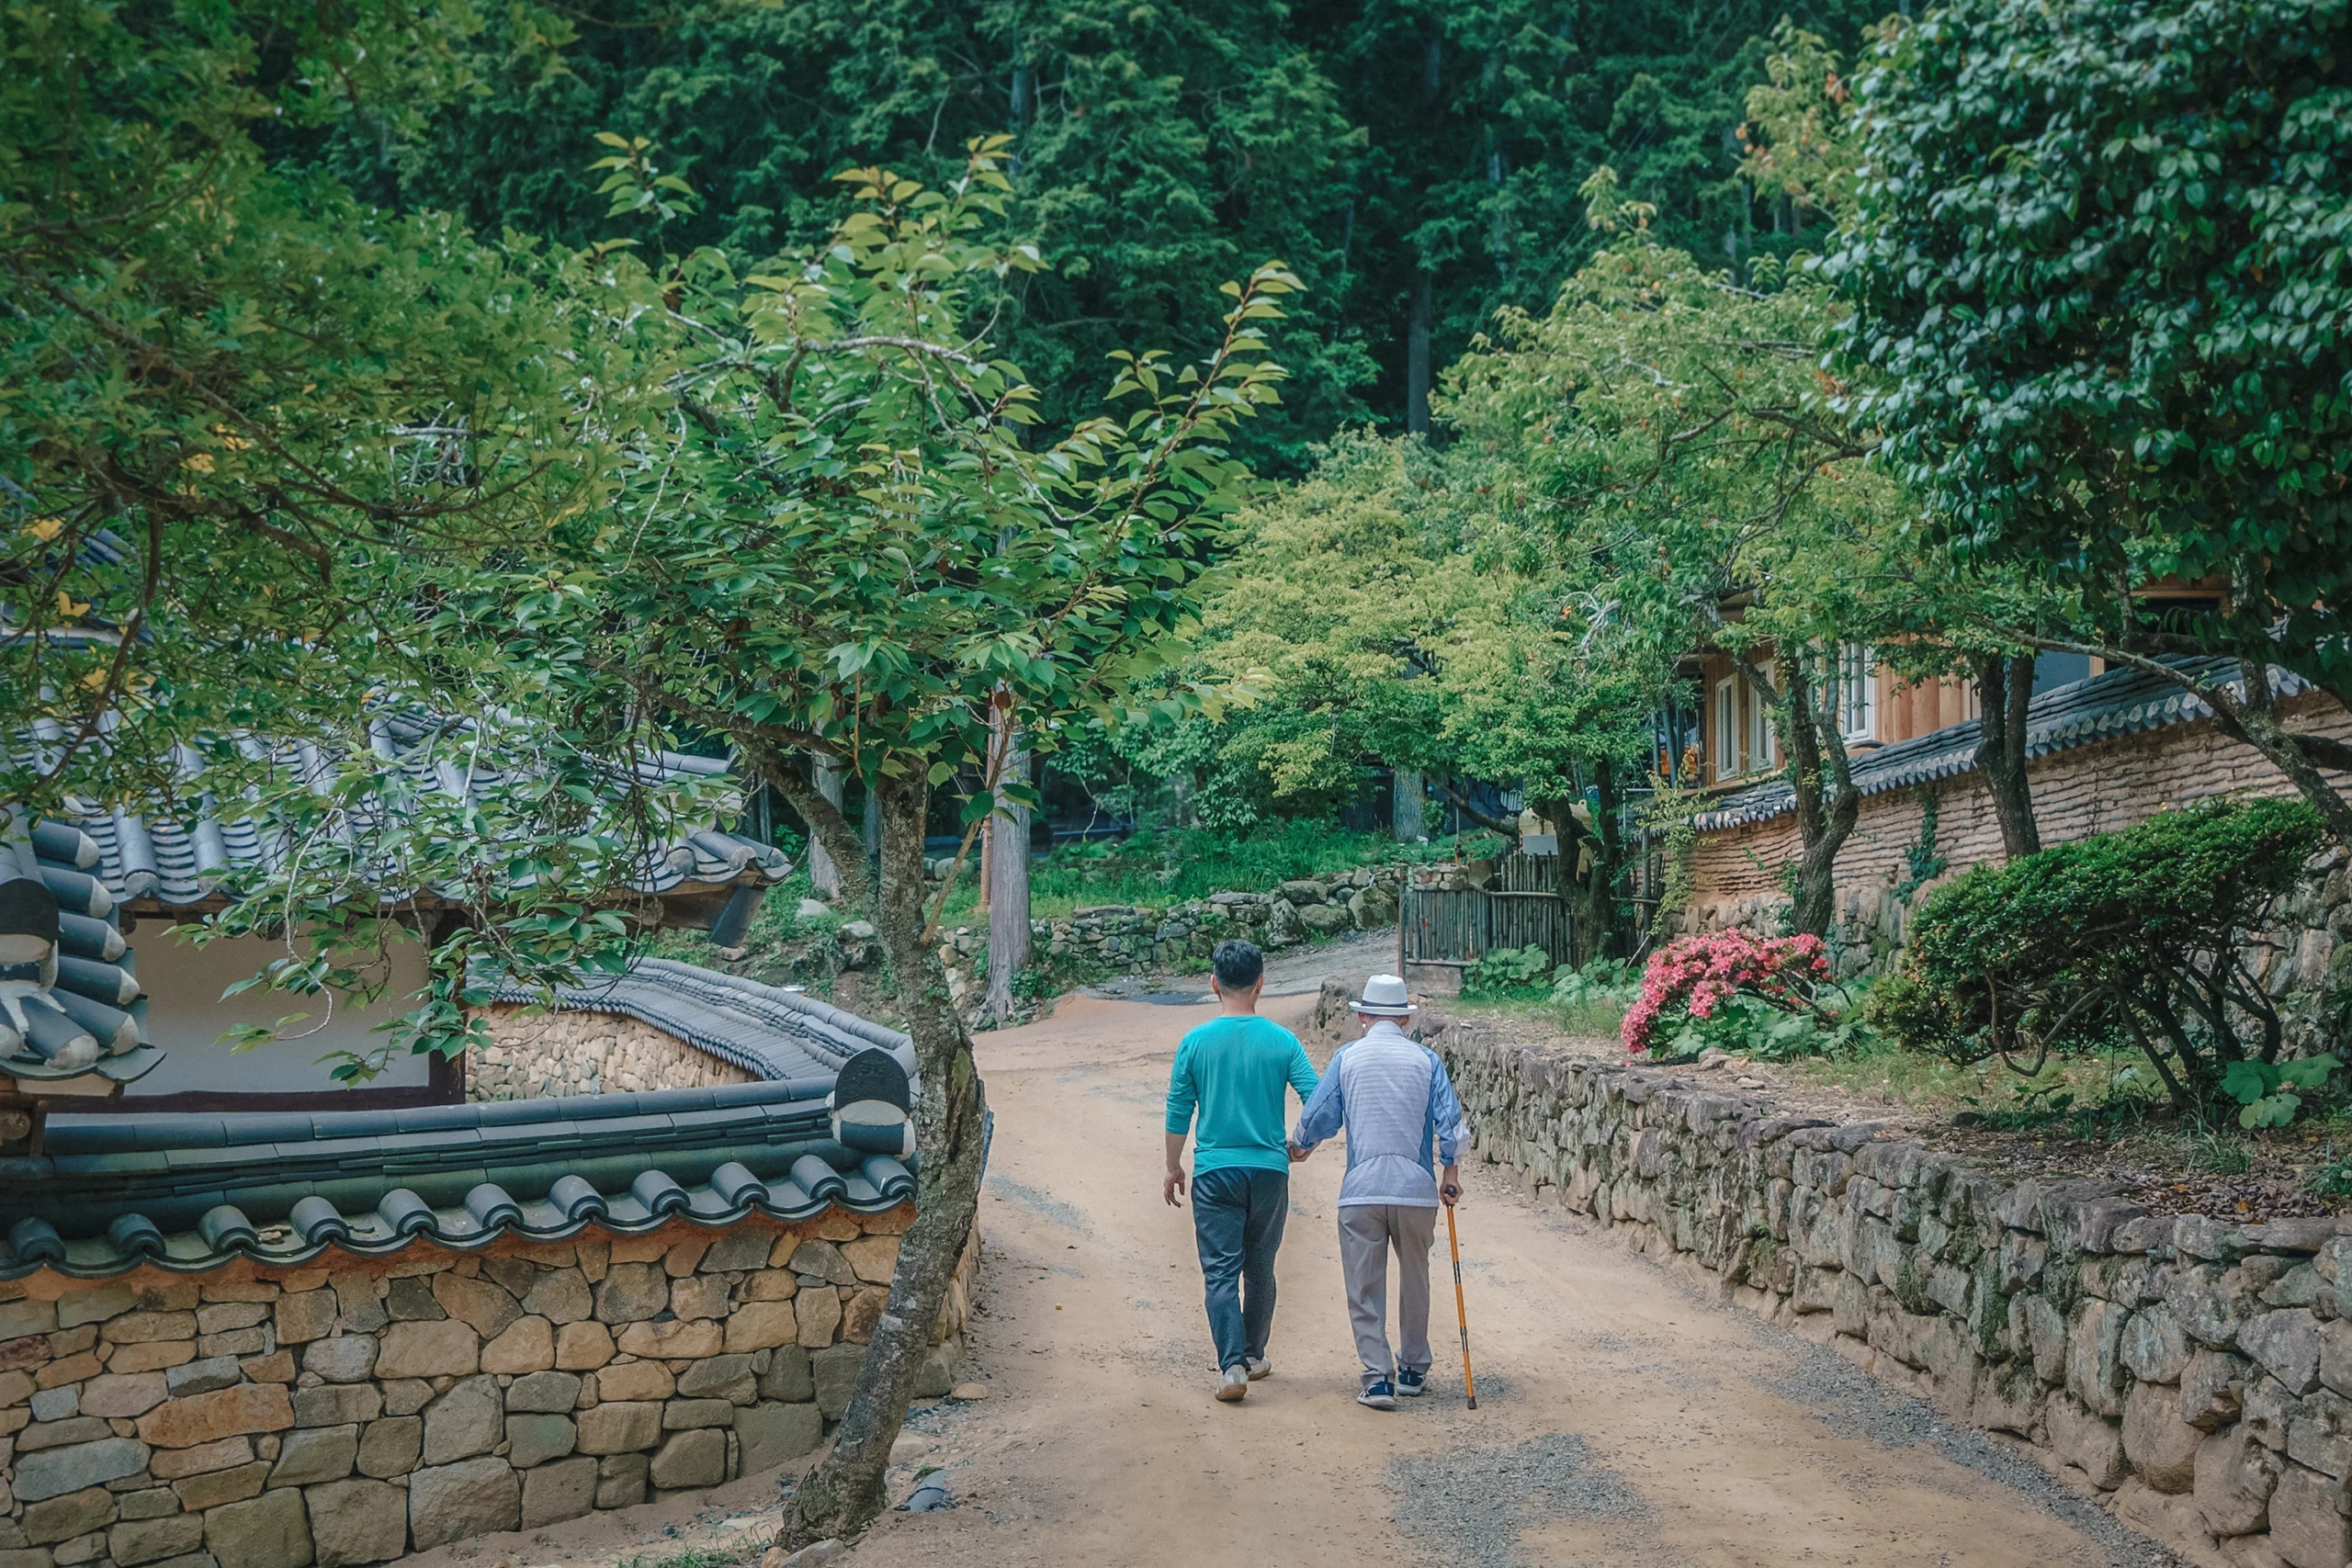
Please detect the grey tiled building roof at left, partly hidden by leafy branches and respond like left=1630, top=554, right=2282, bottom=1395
left=45, top=717, right=790, bottom=909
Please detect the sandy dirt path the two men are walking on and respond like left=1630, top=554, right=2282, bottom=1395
left=413, top=949, right=2171, bottom=1568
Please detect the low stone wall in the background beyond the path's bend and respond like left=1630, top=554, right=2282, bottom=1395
left=938, top=865, right=1408, bottom=1001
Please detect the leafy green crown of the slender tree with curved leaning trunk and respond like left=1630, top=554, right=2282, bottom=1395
left=465, top=136, right=1296, bottom=818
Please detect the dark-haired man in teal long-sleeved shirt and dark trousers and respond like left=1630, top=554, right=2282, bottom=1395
left=1162, top=942, right=1315, bottom=1404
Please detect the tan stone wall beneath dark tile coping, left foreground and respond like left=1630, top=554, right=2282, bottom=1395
left=0, top=1206, right=978, bottom=1568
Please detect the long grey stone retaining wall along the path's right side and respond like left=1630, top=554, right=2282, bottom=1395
left=1425, top=1021, right=2352, bottom=1568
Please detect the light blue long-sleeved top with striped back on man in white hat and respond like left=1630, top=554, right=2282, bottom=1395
left=1291, top=1018, right=1467, bottom=1208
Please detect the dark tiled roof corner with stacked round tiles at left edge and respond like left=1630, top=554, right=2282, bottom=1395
left=0, top=816, right=163, bottom=1096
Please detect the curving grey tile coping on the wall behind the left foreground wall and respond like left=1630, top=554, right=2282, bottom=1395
left=470, top=959, right=915, bottom=1093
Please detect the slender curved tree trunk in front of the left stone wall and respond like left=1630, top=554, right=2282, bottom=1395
left=776, top=760, right=988, bottom=1551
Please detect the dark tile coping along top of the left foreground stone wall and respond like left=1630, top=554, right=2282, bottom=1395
left=0, top=1081, right=915, bottom=1279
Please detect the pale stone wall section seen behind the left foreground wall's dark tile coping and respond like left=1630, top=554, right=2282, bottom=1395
left=466, top=1004, right=755, bottom=1100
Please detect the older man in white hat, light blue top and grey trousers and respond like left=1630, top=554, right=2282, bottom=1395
left=1291, top=976, right=1465, bottom=1411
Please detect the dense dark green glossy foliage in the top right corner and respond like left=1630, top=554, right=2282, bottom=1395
left=1823, top=0, right=2352, bottom=738
